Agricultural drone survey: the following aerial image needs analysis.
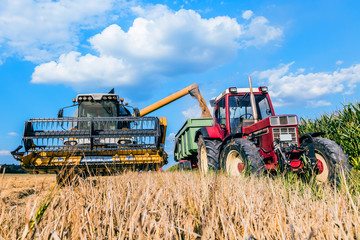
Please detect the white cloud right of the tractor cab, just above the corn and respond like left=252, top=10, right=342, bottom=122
left=253, top=62, right=360, bottom=107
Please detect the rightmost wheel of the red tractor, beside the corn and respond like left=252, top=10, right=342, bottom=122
left=313, top=137, right=351, bottom=182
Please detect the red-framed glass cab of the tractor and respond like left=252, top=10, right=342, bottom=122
left=213, top=87, right=275, bottom=135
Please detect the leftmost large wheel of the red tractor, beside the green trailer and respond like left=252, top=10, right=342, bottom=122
left=197, top=135, right=221, bottom=174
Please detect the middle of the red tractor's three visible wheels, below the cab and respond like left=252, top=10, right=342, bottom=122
left=220, top=138, right=266, bottom=176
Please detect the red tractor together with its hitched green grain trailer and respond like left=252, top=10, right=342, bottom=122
left=174, top=77, right=351, bottom=182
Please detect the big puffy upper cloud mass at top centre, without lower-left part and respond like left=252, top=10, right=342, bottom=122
left=90, top=5, right=241, bottom=72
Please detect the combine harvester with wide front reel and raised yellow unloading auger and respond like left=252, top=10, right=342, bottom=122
left=12, top=84, right=211, bottom=181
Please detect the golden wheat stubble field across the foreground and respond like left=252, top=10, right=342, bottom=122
left=0, top=172, right=360, bottom=239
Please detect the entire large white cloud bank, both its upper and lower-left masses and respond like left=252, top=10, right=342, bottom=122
left=32, top=5, right=282, bottom=88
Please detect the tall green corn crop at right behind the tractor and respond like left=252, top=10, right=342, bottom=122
left=299, top=102, right=360, bottom=170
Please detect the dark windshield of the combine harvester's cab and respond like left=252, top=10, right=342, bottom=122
left=79, top=101, right=118, bottom=117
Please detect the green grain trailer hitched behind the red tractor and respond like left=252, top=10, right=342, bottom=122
left=174, top=118, right=214, bottom=161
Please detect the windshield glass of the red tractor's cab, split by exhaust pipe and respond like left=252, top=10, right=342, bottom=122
left=229, top=93, right=273, bottom=132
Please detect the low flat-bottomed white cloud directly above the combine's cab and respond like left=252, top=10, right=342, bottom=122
left=31, top=52, right=135, bottom=89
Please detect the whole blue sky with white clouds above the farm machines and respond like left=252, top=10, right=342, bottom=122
left=0, top=0, right=360, bottom=165
